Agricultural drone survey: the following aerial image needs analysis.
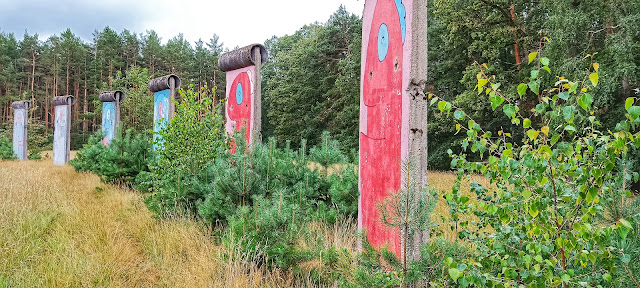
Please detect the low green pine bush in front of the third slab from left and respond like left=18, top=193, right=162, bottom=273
left=69, top=130, right=151, bottom=187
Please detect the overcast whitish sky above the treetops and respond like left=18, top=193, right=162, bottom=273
left=0, top=0, right=364, bottom=48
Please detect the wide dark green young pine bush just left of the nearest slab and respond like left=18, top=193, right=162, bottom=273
left=194, top=137, right=358, bottom=268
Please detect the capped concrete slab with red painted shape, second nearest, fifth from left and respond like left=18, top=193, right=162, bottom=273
left=219, top=44, right=267, bottom=152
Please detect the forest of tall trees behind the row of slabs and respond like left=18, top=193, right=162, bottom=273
left=0, top=0, right=640, bottom=170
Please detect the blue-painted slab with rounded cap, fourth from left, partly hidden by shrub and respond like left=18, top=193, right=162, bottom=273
left=149, top=74, right=181, bottom=150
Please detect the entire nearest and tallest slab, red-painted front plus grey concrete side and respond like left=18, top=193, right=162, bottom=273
left=358, top=0, right=428, bottom=260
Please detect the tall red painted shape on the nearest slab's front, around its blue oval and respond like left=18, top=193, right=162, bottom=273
left=360, top=0, right=403, bottom=256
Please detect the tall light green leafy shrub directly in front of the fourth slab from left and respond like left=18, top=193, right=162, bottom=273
left=141, top=87, right=229, bottom=215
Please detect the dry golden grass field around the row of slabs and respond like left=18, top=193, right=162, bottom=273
left=0, top=159, right=480, bottom=287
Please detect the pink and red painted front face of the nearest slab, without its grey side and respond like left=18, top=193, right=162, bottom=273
left=358, top=0, right=413, bottom=256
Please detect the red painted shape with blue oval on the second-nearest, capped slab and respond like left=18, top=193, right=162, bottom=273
left=227, top=72, right=253, bottom=153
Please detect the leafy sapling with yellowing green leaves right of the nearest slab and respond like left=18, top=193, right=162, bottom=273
left=430, top=51, right=640, bottom=287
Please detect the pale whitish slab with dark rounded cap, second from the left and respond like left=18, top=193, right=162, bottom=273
left=51, top=95, right=76, bottom=166
